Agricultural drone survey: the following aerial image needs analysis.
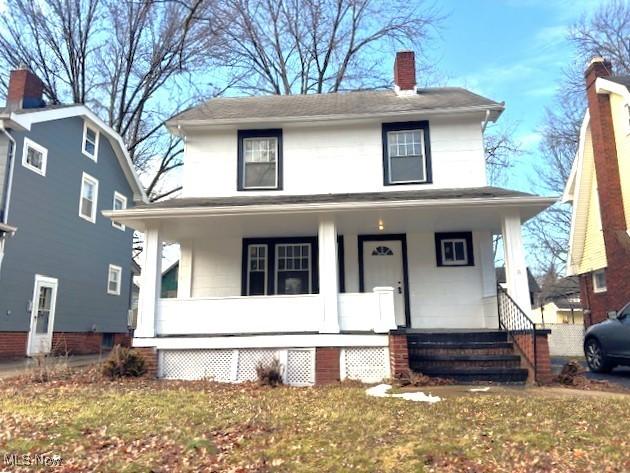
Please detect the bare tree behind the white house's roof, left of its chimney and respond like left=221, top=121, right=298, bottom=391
left=215, top=0, right=441, bottom=95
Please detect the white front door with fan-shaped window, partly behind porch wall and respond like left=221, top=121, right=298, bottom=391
left=363, top=240, right=407, bottom=326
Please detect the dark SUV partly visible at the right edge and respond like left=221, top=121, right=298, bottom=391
left=584, top=302, right=630, bottom=373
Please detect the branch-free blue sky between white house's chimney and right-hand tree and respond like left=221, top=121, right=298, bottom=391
left=433, top=0, right=602, bottom=193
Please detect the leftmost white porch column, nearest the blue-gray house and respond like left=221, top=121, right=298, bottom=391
left=134, top=228, right=162, bottom=338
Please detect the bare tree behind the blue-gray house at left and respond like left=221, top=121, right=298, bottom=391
left=0, top=0, right=220, bottom=200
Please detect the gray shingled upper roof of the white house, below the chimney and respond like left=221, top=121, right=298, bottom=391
left=166, top=87, right=504, bottom=129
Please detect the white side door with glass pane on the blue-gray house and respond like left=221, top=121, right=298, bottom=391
left=28, top=274, right=57, bottom=356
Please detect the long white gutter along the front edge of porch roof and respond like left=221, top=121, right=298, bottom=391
left=101, top=197, right=558, bottom=220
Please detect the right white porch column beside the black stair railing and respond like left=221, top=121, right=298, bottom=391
left=501, top=212, right=532, bottom=316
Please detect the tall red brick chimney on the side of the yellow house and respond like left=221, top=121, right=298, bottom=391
left=582, top=57, right=630, bottom=323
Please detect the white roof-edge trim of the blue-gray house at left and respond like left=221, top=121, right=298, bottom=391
left=0, top=104, right=148, bottom=202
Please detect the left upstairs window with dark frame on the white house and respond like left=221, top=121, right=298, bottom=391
left=238, top=129, right=282, bottom=190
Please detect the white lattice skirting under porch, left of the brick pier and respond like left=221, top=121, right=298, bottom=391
left=158, top=348, right=315, bottom=386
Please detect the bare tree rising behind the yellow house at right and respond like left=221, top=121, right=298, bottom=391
left=528, top=0, right=630, bottom=271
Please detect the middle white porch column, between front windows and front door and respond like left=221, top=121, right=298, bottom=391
left=318, top=218, right=339, bottom=333
